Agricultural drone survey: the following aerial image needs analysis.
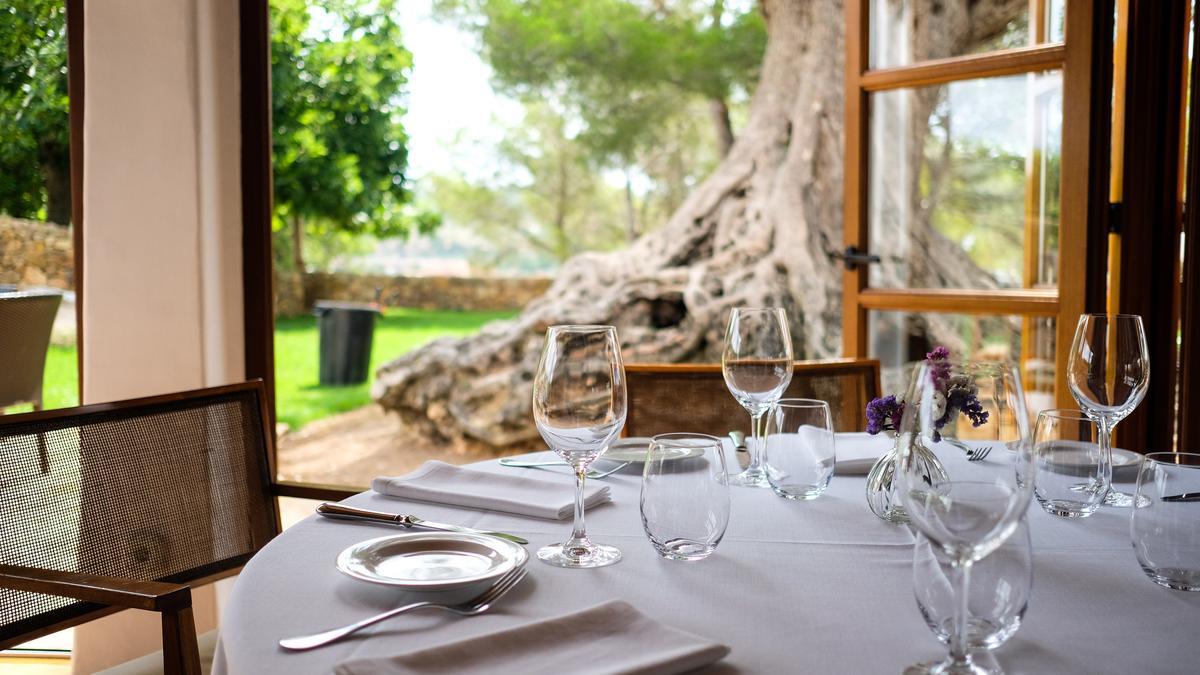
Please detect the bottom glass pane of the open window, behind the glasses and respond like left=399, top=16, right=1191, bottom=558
left=868, top=310, right=1056, bottom=416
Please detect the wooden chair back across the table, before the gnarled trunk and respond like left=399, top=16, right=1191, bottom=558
left=624, top=359, right=880, bottom=437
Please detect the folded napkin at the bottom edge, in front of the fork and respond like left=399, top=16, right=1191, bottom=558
left=335, top=601, right=730, bottom=675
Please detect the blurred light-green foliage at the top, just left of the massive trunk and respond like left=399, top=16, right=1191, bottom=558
left=437, top=0, right=767, bottom=166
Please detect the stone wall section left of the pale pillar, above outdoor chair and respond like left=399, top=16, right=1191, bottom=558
left=0, top=214, right=74, bottom=289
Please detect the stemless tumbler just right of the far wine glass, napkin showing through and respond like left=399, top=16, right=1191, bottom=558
left=763, top=399, right=835, bottom=501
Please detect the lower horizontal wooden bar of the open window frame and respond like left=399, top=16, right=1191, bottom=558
left=859, top=288, right=1058, bottom=316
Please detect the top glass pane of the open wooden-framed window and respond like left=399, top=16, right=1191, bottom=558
left=870, top=0, right=1066, bottom=68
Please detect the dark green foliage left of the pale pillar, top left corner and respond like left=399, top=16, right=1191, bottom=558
left=0, top=0, right=71, bottom=225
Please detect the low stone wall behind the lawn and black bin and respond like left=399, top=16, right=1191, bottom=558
left=275, top=273, right=551, bottom=316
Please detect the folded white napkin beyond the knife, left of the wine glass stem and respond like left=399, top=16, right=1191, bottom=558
left=371, top=460, right=612, bottom=520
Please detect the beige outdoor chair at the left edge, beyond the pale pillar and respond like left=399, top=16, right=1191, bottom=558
left=0, top=291, right=62, bottom=473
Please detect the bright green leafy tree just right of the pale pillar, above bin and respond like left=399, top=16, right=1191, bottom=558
left=271, top=0, right=438, bottom=269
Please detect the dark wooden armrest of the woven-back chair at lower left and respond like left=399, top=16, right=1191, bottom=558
left=0, top=565, right=192, bottom=611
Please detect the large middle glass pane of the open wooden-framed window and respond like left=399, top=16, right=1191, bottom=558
left=868, top=72, right=1062, bottom=288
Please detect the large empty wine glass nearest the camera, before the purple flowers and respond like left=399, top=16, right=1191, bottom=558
left=896, top=360, right=1034, bottom=675
